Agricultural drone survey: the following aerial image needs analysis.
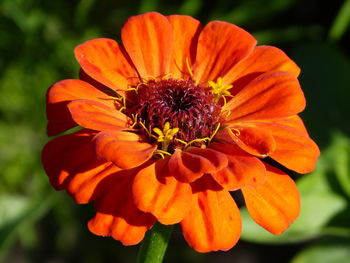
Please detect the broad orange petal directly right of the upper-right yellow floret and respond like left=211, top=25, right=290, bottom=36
left=226, top=72, right=305, bottom=123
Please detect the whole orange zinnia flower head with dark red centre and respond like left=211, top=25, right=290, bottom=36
left=42, top=12, right=319, bottom=252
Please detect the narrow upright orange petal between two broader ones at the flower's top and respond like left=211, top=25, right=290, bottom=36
left=167, top=15, right=202, bottom=78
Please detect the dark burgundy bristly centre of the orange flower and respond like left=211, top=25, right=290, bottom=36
left=126, top=78, right=221, bottom=153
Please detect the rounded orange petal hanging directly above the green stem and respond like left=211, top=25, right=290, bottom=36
left=133, top=160, right=192, bottom=225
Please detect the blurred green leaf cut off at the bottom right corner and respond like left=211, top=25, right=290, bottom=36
left=292, top=240, right=350, bottom=263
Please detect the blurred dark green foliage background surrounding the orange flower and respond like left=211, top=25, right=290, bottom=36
left=0, top=0, right=350, bottom=263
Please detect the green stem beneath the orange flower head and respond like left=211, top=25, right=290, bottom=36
left=137, top=222, right=173, bottom=263
